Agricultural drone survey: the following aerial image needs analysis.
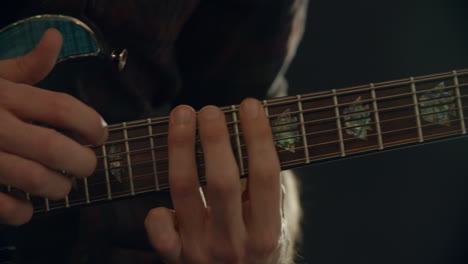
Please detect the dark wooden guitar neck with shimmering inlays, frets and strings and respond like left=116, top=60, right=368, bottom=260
left=4, top=69, right=468, bottom=212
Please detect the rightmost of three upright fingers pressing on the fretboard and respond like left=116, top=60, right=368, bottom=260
left=240, top=98, right=281, bottom=233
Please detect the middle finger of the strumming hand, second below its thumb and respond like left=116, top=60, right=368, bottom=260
left=0, top=111, right=97, bottom=178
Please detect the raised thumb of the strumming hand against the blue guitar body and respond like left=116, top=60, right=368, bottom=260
left=0, top=28, right=62, bottom=84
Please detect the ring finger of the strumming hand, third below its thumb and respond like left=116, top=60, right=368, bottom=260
left=0, top=152, right=72, bottom=200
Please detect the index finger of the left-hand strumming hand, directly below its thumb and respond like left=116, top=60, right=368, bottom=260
left=0, top=80, right=108, bottom=145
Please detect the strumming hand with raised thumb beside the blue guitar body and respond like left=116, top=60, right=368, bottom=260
left=0, top=29, right=107, bottom=225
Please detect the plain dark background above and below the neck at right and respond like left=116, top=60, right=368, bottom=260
left=288, top=0, right=468, bottom=264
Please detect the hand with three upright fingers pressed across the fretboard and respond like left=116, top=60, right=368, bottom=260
left=145, top=99, right=287, bottom=264
